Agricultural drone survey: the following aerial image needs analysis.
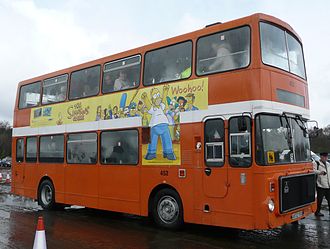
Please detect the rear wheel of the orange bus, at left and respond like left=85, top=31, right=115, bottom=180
left=38, top=180, right=55, bottom=210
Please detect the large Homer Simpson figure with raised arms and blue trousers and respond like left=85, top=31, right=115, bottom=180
left=141, top=86, right=176, bottom=160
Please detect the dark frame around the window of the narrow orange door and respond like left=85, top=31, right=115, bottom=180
left=203, top=116, right=226, bottom=168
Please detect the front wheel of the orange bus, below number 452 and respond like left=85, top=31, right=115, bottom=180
left=152, top=189, right=183, bottom=229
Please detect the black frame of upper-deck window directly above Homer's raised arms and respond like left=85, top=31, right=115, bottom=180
left=141, top=39, right=194, bottom=87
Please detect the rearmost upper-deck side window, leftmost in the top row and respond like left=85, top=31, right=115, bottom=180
left=18, top=82, right=41, bottom=109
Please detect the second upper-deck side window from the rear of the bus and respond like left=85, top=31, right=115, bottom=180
left=42, top=74, right=68, bottom=105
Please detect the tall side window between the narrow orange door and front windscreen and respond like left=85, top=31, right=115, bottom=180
left=229, top=116, right=252, bottom=167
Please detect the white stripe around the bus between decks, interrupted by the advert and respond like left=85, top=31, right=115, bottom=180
left=13, top=100, right=309, bottom=137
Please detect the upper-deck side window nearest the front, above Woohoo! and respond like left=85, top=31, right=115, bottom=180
left=197, top=26, right=250, bottom=75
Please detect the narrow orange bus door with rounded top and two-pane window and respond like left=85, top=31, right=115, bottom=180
left=202, top=118, right=228, bottom=197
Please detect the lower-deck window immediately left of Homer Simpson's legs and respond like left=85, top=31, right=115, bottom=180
left=101, top=130, right=139, bottom=165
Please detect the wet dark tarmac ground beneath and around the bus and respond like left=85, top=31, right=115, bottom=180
left=0, top=167, right=330, bottom=249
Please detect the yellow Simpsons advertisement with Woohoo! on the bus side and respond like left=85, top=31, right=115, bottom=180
left=30, top=78, right=208, bottom=165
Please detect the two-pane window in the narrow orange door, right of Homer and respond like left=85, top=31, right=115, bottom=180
left=204, top=119, right=225, bottom=166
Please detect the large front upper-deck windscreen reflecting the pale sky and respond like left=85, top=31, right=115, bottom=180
left=260, top=22, right=306, bottom=79
